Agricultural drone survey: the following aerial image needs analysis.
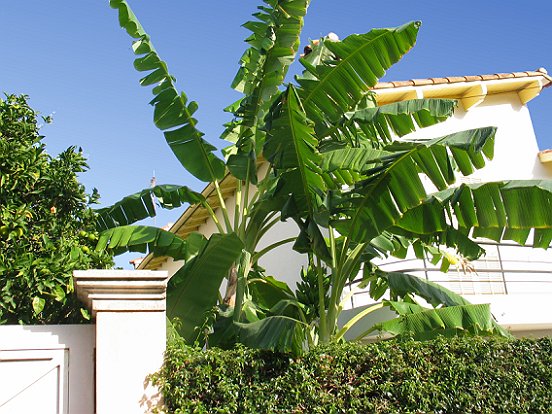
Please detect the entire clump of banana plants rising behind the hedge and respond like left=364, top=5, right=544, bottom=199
left=97, top=0, right=552, bottom=352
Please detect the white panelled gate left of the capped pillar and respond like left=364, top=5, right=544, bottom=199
left=0, top=325, right=94, bottom=414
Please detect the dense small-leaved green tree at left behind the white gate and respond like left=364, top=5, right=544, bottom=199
left=0, top=95, right=112, bottom=324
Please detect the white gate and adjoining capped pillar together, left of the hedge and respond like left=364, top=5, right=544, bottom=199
left=0, top=270, right=167, bottom=414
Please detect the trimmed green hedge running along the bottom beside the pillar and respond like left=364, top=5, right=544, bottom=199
left=154, top=338, right=552, bottom=413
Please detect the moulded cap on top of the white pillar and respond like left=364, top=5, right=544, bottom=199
left=73, top=270, right=169, bottom=315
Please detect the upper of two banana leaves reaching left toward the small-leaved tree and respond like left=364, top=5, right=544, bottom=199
left=96, top=185, right=205, bottom=230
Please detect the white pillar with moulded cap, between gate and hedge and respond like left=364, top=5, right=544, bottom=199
left=74, top=270, right=168, bottom=414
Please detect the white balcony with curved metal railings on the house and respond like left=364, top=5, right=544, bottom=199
left=346, top=242, right=552, bottom=336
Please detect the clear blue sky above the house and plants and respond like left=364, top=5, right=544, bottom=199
left=0, top=0, right=552, bottom=265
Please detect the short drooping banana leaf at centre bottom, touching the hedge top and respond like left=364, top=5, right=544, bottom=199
left=235, top=316, right=308, bottom=355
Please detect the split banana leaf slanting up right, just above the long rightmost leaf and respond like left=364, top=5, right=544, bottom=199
left=332, top=127, right=496, bottom=242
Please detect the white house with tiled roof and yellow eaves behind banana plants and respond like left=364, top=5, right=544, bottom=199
left=138, top=69, right=552, bottom=336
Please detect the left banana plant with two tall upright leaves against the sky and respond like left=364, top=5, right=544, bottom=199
left=101, top=0, right=309, bottom=343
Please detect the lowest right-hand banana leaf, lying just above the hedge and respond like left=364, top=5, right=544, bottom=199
left=373, top=302, right=505, bottom=340
